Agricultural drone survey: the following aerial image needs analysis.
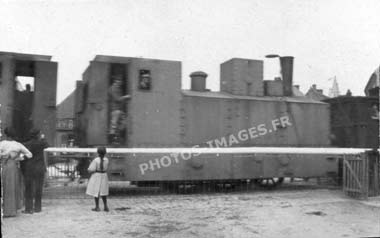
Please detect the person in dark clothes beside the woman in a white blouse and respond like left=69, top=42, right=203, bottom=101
left=22, top=129, right=49, bottom=214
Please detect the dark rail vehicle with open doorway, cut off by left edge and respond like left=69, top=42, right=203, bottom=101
left=0, top=52, right=57, bottom=145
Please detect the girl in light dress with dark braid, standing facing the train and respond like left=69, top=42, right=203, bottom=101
left=86, top=146, right=109, bottom=212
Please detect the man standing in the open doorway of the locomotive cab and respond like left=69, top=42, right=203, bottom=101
left=108, top=75, right=131, bottom=143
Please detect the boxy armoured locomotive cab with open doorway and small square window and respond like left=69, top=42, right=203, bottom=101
left=75, top=55, right=181, bottom=147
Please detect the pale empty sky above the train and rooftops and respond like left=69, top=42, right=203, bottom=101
left=0, top=0, right=380, bottom=102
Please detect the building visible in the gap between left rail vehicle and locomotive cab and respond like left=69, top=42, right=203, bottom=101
left=55, top=92, right=75, bottom=147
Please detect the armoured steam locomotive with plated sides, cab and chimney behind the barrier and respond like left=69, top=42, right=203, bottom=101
left=75, top=55, right=338, bottom=184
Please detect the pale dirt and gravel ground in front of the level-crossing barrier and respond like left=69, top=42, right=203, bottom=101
left=2, top=188, right=380, bottom=238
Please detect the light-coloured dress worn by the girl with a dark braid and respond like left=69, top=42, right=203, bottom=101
left=86, top=157, right=109, bottom=197
